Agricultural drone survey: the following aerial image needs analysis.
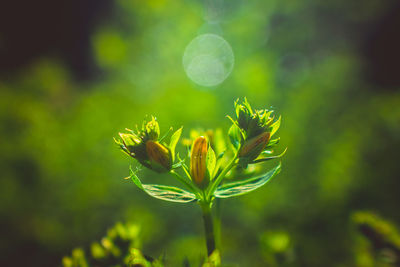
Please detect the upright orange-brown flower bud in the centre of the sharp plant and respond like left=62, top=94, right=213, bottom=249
left=190, top=136, right=208, bottom=185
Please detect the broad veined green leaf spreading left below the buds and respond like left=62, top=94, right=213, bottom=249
left=130, top=165, right=197, bottom=203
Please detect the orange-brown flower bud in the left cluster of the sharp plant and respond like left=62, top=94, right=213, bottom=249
left=146, top=141, right=172, bottom=172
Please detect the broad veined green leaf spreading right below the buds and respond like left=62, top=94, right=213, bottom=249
left=214, top=163, right=281, bottom=198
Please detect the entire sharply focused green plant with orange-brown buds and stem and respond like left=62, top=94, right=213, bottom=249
left=115, top=98, right=286, bottom=255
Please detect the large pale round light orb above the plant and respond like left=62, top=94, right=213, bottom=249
left=183, top=33, right=234, bottom=87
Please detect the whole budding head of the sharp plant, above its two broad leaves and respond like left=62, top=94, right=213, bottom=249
left=115, top=98, right=283, bottom=196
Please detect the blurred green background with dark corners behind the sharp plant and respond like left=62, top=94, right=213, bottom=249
left=0, top=0, right=400, bottom=266
